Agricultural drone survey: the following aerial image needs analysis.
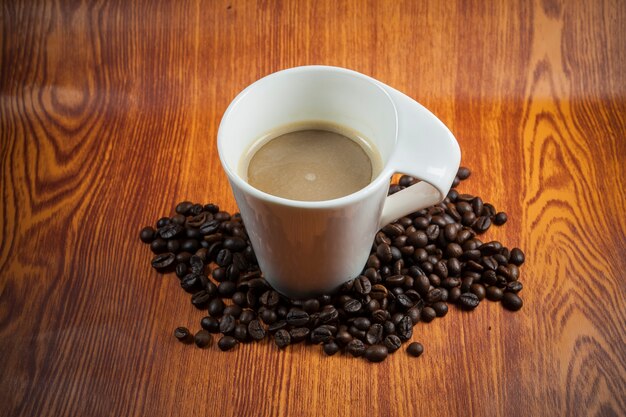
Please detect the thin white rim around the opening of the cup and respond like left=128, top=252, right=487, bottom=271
left=217, top=65, right=398, bottom=209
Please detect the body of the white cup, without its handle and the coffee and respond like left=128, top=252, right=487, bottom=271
left=218, top=67, right=397, bottom=297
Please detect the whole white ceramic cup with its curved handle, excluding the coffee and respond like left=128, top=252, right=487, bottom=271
left=217, top=66, right=461, bottom=298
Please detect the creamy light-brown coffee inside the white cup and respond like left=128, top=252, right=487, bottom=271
left=240, top=121, right=382, bottom=201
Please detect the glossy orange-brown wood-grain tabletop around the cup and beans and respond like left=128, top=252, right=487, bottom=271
left=0, top=0, right=626, bottom=416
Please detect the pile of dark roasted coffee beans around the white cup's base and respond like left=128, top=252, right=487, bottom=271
left=140, top=167, right=524, bottom=362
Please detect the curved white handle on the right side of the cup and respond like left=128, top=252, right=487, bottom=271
left=379, top=85, right=461, bottom=227
